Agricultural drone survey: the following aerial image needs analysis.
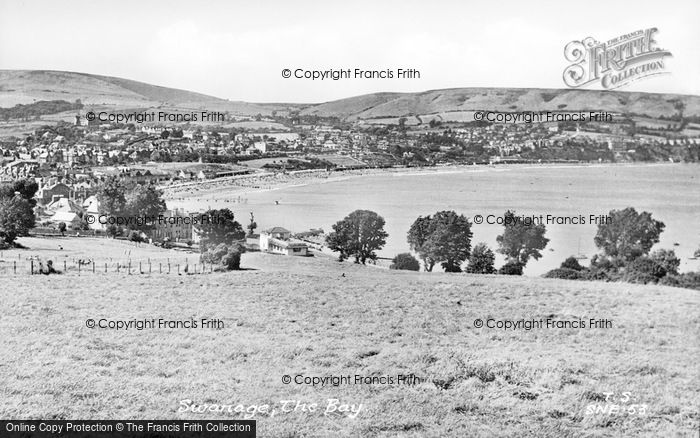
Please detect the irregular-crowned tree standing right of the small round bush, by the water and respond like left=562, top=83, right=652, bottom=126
left=496, top=210, right=549, bottom=266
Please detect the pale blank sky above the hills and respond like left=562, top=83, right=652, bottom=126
left=0, top=0, right=700, bottom=103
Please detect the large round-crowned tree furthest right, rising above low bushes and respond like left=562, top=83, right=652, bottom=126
left=594, top=207, right=665, bottom=261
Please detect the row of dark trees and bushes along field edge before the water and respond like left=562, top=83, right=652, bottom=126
left=326, top=207, right=700, bottom=289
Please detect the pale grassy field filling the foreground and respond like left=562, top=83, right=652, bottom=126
left=0, top=239, right=700, bottom=437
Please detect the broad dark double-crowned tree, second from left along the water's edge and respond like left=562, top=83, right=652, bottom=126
left=408, top=211, right=472, bottom=272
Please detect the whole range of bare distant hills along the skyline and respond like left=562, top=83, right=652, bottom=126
left=0, top=70, right=700, bottom=121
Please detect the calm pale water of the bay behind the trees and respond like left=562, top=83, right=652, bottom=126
left=172, top=163, right=700, bottom=276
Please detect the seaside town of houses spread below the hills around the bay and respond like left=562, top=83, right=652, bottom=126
left=0, top=101, right=700, bottom=250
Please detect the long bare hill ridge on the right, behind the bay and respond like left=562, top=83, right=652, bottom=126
left=302, top=88, right=700, bottom=120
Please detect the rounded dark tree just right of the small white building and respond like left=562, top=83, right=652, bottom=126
left=326, top=210, right=388, bottom=265
